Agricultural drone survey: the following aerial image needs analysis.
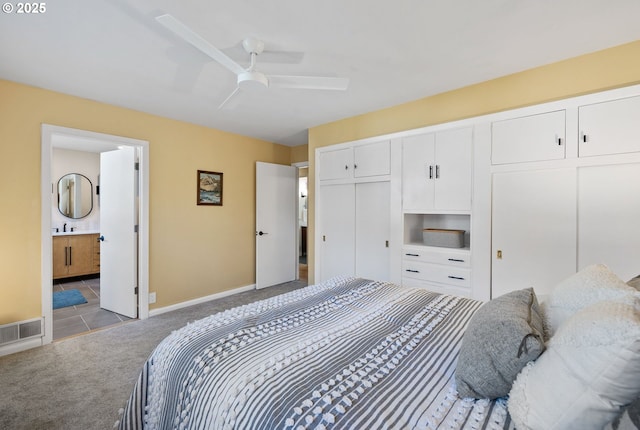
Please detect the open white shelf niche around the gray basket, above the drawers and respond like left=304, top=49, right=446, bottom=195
left=404, top=214, right=471, bottom=249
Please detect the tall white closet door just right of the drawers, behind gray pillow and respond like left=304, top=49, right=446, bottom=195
left=491, top=169, right=577, bottom=298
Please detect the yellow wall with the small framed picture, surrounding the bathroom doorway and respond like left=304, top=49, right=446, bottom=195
left=0, top=80, right=292, bottom=325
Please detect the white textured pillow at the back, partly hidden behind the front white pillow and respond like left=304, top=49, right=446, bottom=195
left=542, top=264, right=640, bottom=336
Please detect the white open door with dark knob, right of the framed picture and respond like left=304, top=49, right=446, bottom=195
left=256, top=162, right=298, bottom=288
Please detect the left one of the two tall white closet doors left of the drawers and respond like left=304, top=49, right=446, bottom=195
left=318, top=184, right=355, bottom=281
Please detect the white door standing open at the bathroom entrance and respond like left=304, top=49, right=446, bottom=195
left=100, top=146, right=138, bottom=318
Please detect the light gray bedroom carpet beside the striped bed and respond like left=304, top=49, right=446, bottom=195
left=0, top=281, right=306, bottom=430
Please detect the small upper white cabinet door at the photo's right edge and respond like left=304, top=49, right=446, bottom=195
left=578, top=97, right=640, bottom=157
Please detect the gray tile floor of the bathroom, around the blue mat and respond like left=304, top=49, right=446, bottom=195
left=53, top=277, right=131, bottom=340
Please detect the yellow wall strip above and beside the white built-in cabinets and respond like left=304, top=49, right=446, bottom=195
left=307, top=41, right=640, bottom=283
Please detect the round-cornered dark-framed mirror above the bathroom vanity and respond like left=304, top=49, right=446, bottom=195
left=58, top=173, right=93, bottom=219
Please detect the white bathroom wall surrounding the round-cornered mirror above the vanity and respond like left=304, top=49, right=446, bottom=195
left=51, top=148, right=100, bottom=231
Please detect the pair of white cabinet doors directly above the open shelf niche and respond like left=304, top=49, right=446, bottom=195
left=402, top=127, right=473, bottom=212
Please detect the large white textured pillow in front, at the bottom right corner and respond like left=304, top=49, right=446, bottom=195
left=508, top=296, right=640, bottom=430
